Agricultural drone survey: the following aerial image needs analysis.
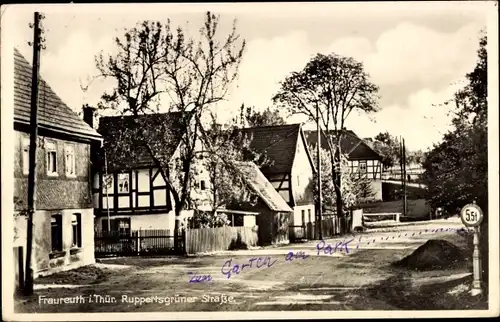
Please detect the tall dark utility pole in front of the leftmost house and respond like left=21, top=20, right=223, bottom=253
left=24, top=12, right=43, bottom=295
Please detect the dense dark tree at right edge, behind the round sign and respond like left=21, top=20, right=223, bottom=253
left=423, top=36, right=488, bottom=281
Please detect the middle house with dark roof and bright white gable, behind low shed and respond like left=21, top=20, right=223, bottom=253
left=240, top=124, right=316, bottom=238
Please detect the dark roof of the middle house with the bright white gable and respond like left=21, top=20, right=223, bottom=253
left=238, top=124, right=309, bottom=174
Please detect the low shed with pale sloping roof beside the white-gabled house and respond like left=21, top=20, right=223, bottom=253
left=228, top=162, right=293, bottom=245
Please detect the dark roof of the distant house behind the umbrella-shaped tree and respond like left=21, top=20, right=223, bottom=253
left=304, top=130, right=382, bottom=160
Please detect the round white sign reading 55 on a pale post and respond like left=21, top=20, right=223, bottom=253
left=460, top=202, right=483, bottom=296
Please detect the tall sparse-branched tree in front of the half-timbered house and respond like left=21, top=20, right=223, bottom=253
left=96, top=12, right=245, bottom=247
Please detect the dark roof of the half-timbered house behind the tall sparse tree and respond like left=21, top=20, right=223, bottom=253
left=98, top=112, right=185, bottom=172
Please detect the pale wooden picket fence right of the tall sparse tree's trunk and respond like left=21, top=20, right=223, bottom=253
left=185, top=226, right=259, bottom=254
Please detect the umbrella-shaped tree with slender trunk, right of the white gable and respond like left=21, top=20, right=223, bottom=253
left=273, top=54, right=378, bottom=219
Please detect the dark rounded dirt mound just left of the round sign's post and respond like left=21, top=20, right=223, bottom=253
left=393, top=239, right=468, bottom=271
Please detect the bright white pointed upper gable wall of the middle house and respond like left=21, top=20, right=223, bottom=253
left=292, top=135, right=314, bottom=205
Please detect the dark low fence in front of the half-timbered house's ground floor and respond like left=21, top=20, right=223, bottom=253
left=94, top=229, right=184, bottom=257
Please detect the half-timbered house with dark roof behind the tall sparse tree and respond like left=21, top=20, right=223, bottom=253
left=93, top=112, right=185, bottom=235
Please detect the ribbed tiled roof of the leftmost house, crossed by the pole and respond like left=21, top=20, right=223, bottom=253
left=14, top=49, right=101, bottom=140
